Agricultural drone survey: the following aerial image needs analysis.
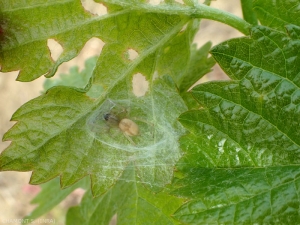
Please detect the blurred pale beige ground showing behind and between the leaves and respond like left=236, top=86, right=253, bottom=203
left=0, top=0, right=242, bottom=224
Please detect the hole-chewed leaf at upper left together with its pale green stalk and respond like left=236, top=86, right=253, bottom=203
left=0, top=0, right=249, bottom=81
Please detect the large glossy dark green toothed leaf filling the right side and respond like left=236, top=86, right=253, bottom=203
left=173, top=26, right=300, bottom=224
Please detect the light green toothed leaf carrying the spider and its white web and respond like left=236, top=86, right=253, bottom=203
left=0, top=3, right=195, bottom=196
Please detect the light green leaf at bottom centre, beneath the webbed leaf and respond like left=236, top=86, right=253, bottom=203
left=67, top=165, right=182, bottom=225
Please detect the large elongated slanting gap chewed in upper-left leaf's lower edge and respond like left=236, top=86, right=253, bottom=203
left=56, top=38, right=104, bottom=74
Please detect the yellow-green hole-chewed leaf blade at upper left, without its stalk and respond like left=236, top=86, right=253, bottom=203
left=0, top=0, right=185, bottom=81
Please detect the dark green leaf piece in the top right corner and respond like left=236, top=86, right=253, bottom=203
left=253, top=0, right=300, bottom=31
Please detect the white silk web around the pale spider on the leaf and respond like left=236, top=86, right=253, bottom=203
left=86, top=99, right=182, bottom=188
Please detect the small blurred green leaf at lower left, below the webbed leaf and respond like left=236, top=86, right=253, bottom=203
left=24, top=176, right=89, bottom=220
